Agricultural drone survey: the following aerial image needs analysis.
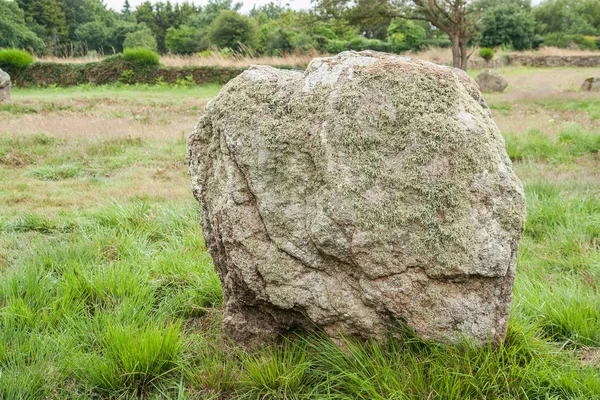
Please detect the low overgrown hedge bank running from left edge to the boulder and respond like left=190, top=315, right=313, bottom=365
left=1, top=58, right=244, bottom=87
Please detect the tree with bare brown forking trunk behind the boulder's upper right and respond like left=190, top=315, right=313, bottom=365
left=413, top=0, right=478, bottom=70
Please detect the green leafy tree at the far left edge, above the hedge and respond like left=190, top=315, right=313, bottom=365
left=0, top=0, right=45, bottom=54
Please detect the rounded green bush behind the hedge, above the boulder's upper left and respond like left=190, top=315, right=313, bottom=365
left=208, top=10, right=257, bottom=50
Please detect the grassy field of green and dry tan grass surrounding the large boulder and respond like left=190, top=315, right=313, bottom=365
left=0, top=68, right=600, bottom=400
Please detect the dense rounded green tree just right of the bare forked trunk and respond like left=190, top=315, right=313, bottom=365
left=480, top=2, right=535, bottom=50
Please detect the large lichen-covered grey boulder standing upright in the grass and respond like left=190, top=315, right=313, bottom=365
left=187, top=52, right=525, bottom=346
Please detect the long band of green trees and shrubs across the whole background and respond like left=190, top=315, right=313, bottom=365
left=0, top=0, right=600, bottom=62
